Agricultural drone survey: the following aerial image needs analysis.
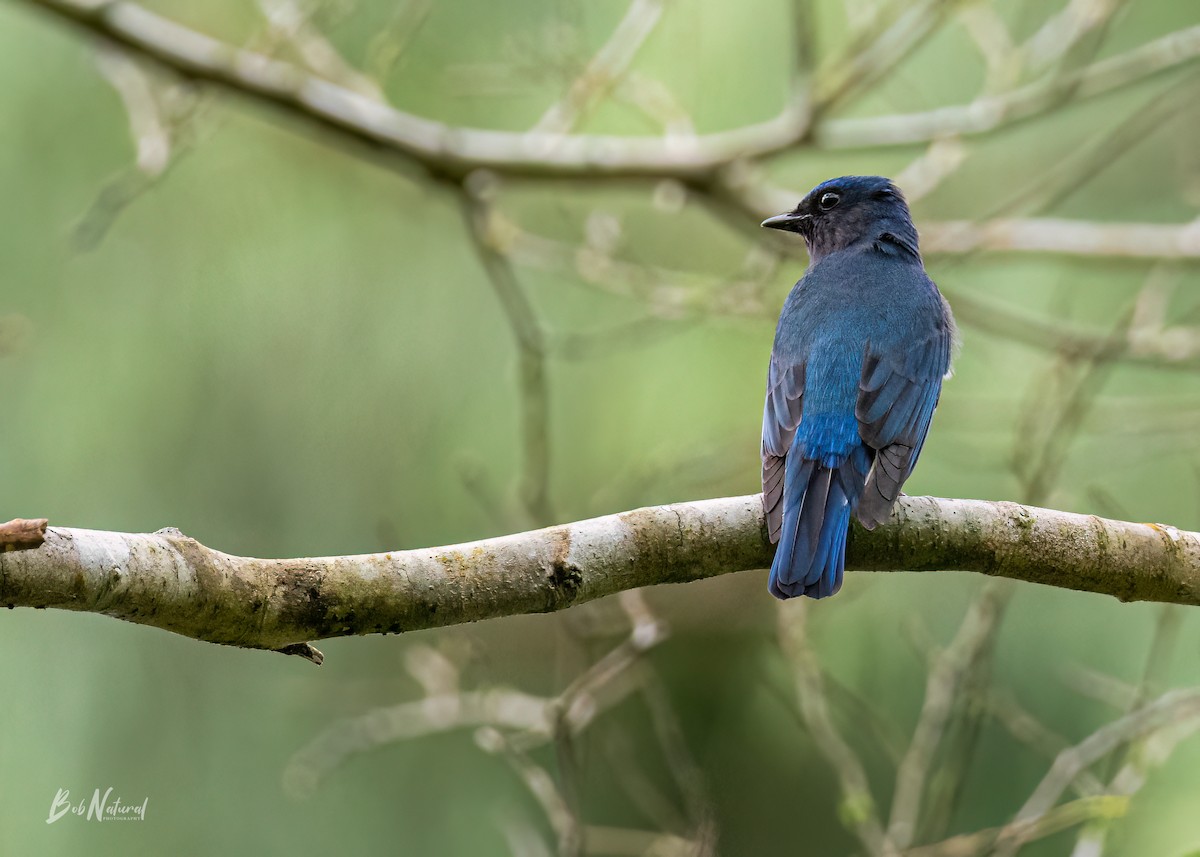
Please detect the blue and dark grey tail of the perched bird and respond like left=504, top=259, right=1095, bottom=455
left=769, top=450, right=868, bottom=598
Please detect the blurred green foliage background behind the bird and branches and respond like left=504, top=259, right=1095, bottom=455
left=0, top=0, right=1200, bottom=857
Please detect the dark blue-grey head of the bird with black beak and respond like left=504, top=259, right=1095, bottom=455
left=762, top=175, right=920, bottom=262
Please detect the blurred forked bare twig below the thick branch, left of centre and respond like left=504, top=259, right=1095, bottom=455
left=284, top=589, right=691, bottom=857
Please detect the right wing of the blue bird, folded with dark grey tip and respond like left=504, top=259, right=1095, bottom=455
left=854, top=325, right=953, bottom=529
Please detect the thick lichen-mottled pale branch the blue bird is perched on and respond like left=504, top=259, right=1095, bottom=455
left=0, top=495, right=1200, bottom=658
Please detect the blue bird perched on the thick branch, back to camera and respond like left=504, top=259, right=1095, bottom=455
left=762, top=175, right=958, bottom=599
